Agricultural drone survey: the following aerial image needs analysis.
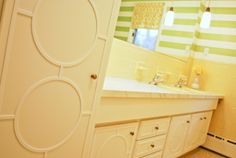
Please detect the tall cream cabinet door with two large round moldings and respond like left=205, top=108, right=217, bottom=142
left=0, top=0, right=119, bottom=158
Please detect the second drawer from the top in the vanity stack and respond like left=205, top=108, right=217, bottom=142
left=134, top=135, right=166, bottom=157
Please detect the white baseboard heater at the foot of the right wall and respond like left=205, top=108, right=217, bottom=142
left=202, top=135, right=236, bottom=158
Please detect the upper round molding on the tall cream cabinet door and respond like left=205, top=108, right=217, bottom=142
left=32, top=0, right=98, bottom=67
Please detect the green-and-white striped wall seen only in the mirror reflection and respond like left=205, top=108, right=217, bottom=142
left=115, top=0, right=200, bottom=55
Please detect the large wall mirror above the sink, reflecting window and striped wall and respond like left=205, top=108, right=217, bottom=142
left=115, top=0, right=201, bottom=61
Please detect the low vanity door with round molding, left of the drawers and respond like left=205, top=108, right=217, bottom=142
left=91, top=123, right=138, bottom=158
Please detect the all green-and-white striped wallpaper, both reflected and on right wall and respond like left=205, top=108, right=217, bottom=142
left=115, top=0, right=236, bottom=61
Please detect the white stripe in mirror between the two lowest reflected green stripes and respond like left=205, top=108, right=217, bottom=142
left=159, top=35, right=193, bottom=44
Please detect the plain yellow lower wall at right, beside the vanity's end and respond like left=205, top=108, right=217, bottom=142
left=193, top=59, right=236, bottom=140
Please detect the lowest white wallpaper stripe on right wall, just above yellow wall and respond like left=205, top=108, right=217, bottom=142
left=194, top=52, right=236, bottom=64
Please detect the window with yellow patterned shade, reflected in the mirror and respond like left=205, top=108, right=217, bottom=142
left=129, top=2, right=164, bottom=51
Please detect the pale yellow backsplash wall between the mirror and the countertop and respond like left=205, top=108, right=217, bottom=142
left=107, top=39, right=187, bottom=82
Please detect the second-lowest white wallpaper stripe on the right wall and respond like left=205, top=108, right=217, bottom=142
left=196, top=39, right=236, bottom=51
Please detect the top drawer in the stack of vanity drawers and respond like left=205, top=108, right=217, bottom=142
left=137, top=118, right=170, bottom=140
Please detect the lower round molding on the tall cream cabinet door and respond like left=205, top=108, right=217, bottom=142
left=14, top=76, right=83, bottom=152
